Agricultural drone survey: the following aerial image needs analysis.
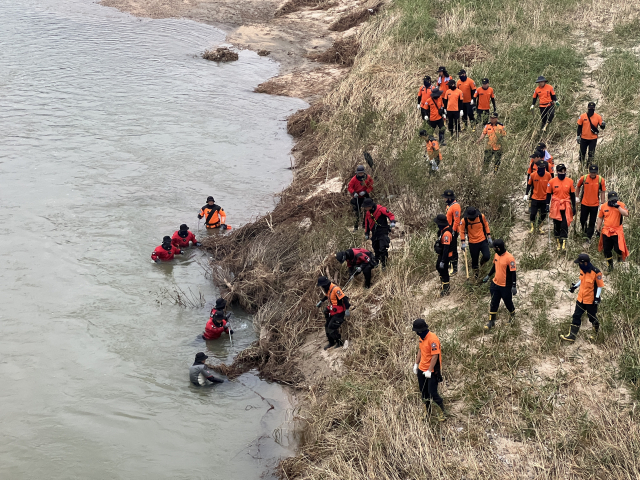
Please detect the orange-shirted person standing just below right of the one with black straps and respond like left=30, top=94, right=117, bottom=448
left=482, top=239, right=518, bottom=330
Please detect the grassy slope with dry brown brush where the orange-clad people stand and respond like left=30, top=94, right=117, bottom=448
left=205, top=0, right=640, bottom=479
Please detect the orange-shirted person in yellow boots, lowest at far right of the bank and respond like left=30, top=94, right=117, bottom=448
left=560, top=253, right=604, bottom=342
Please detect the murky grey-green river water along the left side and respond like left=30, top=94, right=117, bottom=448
left=0, top=0, right=305, bottom=479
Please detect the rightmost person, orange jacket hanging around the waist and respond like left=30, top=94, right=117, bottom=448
left=596, top=192, right=629, bottom=272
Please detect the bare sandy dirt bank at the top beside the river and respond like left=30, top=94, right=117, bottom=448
left=101, top=0, right=370, bottom=102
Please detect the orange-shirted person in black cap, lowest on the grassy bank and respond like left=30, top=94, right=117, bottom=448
left=412, top=318, right=448, bottom=422
